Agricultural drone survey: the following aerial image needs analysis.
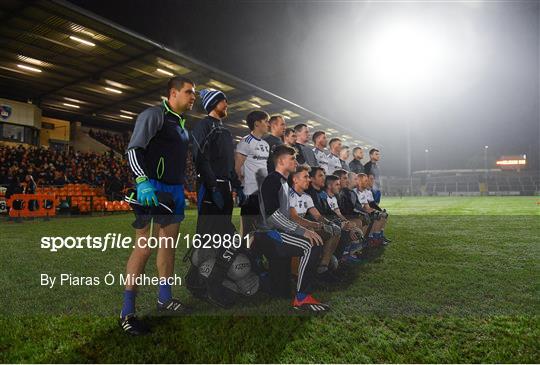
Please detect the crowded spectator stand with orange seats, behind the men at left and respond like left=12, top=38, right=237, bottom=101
left=0, top=140, right=196, bottom=213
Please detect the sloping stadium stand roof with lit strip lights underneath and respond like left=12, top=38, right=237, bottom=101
left=0, top=0, right=373, bottom=147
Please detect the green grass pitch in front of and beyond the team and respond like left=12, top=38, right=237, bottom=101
left=0, top=197, right=540, bottom=363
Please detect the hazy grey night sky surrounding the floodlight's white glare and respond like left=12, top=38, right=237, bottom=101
left=71, top=0, right=540, bottom=175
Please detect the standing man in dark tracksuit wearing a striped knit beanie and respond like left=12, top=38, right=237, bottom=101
left=191, top=89, right=245, bottom=307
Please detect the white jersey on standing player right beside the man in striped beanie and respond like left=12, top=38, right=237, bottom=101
left=236, top=134, right=270, bottom=195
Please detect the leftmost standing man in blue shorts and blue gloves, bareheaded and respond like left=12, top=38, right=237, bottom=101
left=120, top=76, right=195, bottom=335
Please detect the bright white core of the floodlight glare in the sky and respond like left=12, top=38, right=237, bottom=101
left=364, top=15, right=451, bottom=95
